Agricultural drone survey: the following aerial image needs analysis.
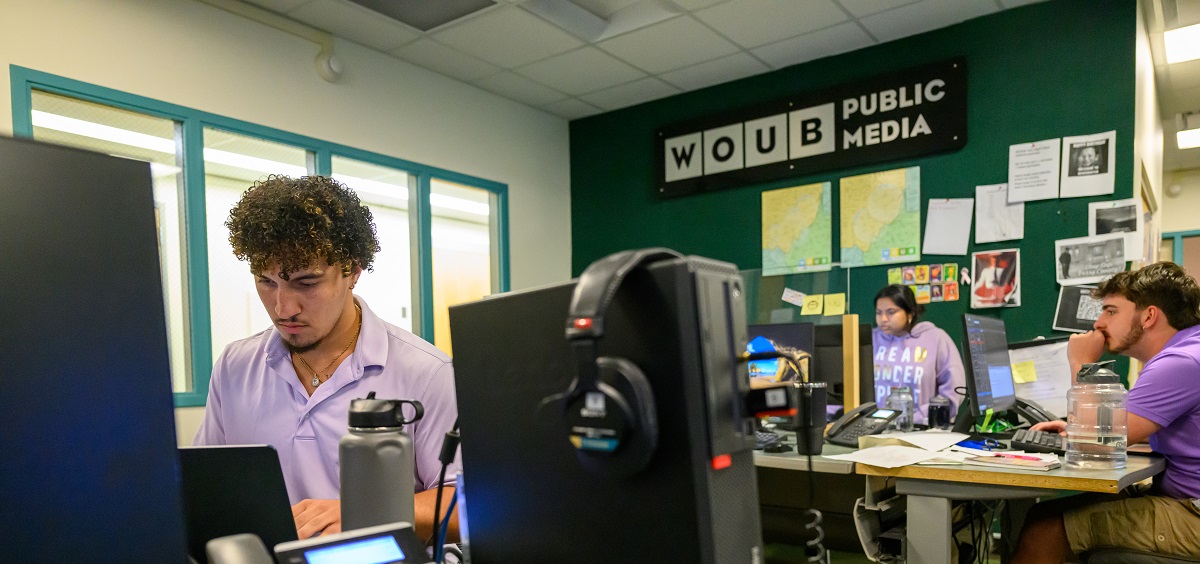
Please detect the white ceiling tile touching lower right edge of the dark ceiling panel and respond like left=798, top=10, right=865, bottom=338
left=432, top=6, right=583, bottom=68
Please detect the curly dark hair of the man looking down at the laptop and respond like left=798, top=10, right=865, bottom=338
left=226, top=174, right=379, bottom=280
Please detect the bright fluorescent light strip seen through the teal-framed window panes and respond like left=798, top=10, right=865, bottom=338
left=32, top=109, right=491, bottom=216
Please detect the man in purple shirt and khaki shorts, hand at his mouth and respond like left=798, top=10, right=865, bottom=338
left=1013, top=263, right=1200, bottom=563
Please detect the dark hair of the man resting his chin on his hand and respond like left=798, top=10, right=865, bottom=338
left=1092, top=262, right=1200, bottom=330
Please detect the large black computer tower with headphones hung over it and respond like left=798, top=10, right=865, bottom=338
left=450, top=257, right=762, bottom=564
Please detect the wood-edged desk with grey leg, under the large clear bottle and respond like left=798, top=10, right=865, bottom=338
left=859, top=456, right=1166, bottom=564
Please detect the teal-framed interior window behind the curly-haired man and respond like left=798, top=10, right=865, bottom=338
left=10, top=65, right=509, bottom=407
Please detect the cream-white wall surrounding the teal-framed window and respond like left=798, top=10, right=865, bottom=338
left=0, top=0, right=571, bottom=438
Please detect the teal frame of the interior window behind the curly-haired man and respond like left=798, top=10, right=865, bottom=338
left=8, top=65, right=509, bottom=407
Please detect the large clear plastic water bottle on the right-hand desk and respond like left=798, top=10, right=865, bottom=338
left=1066, top=361, right=1129, bottom=469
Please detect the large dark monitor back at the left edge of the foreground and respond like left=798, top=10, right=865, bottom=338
left=0, top=138, right=186, bottom=563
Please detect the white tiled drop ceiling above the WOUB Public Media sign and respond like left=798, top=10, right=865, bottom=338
left=244, top=0, right=1040, bottom=119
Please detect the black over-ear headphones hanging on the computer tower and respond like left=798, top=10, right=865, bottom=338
left=546, top=248, right=683, bottom=478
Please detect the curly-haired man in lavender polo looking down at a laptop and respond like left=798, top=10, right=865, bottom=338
left=194, top=176, right=458, bottom=539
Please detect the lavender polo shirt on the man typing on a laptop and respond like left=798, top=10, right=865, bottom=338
left=194, top=296, right=460, bottom=504
